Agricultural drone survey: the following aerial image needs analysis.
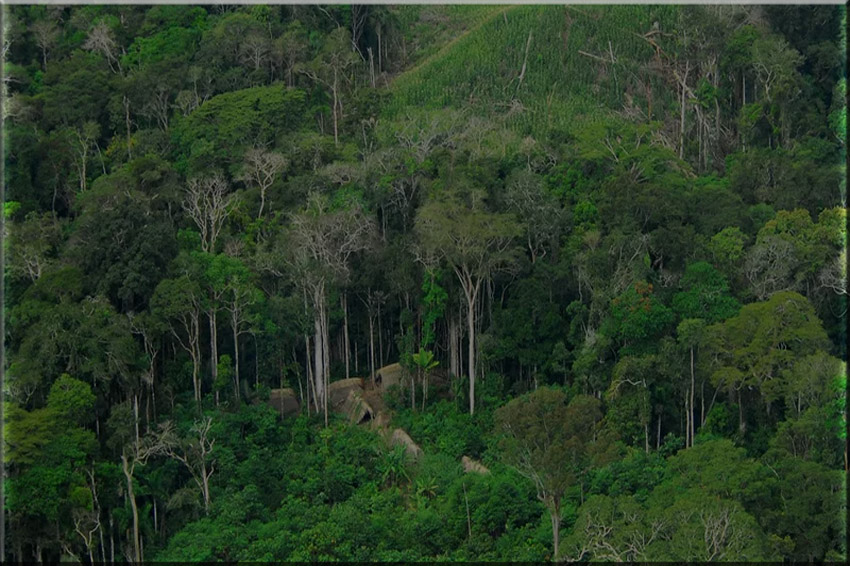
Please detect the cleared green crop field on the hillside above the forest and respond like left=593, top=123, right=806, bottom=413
left=386, top=6, right=677, bottom=134
